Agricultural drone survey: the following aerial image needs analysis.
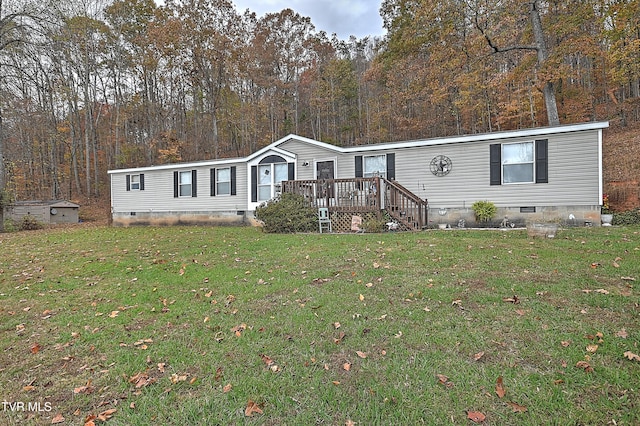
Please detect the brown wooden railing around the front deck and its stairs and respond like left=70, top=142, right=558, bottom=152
left=282, top=177, right=428, bottom=230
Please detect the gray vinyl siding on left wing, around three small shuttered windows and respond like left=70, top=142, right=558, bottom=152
left=111, top=163, right=247, bottom=213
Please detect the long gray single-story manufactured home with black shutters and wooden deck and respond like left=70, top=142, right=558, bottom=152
left=109, top=122, right=608, bottom=231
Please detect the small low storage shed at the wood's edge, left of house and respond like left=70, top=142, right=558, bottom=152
left=4, top=200, right=80, bottom=224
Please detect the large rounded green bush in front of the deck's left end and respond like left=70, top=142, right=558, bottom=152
left=255, top=193, right=318, bottom=234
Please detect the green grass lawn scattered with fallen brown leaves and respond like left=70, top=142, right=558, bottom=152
left=0, top=227, right=640, bottom=425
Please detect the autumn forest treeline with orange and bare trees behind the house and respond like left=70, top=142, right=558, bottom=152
left=0, top=0, right=640, bottom=204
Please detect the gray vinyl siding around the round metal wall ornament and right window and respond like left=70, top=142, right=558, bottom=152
left=396, top=131, right=599, bottom=208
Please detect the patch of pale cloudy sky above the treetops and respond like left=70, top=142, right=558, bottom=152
left=231, top=0, right=384, bottom=40
